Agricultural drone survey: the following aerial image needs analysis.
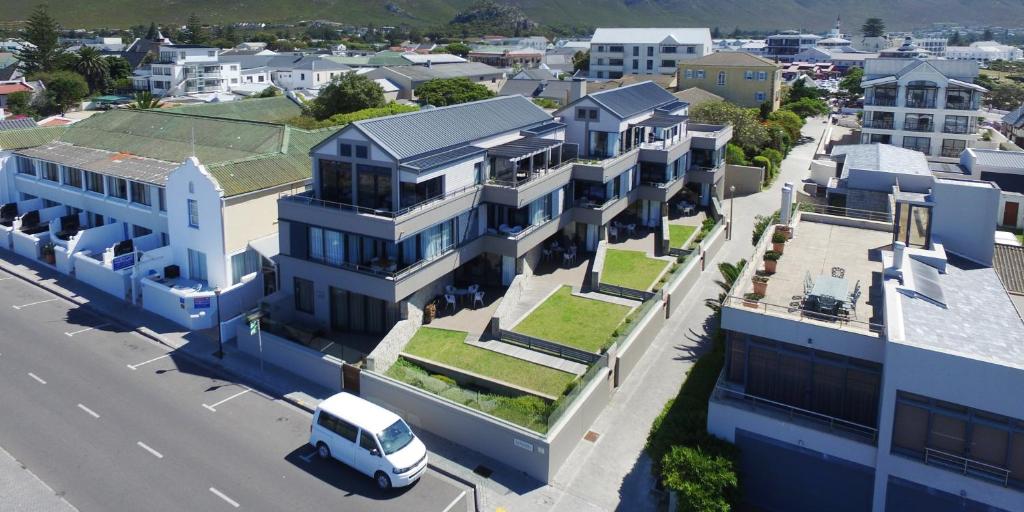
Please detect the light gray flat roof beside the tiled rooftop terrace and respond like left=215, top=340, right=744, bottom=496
left=899, top=256, right=1024, bottom=368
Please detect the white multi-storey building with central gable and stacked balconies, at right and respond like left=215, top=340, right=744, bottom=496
left=861, top=58, right=986, bottom=161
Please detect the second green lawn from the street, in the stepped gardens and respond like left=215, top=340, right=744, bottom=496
left=513, top=286, right=630, bottom=352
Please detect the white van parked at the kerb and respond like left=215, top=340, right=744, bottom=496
left=309, top=393, right=427, bottom=489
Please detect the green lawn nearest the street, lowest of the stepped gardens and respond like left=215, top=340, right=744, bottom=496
left=406, top=327, right=575, bottom=397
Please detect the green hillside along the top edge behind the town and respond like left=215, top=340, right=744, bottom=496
left=6, top=0, right=1024, bottom=32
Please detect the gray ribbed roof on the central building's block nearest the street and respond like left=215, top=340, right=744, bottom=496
left=352, top=96, right=552, bottom=160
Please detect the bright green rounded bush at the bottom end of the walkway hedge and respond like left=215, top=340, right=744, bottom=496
left=662, top=445, right=739, bottom=512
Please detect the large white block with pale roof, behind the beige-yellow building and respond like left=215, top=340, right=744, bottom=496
left=590, top=29, right=713, bottom=79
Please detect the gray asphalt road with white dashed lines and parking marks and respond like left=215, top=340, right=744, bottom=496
left=0, top=272, right=472, bottom=512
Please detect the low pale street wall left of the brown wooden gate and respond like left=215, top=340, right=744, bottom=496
left=236, top=322, right=342, bottom=391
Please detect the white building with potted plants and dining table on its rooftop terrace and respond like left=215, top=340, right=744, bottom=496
left=708, top=172, right=1024, bottom=512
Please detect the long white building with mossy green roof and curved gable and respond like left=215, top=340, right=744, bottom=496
left=0, top=110, right=326, bottom=329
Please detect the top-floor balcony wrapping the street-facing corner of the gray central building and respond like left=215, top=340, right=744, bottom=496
left=278, top=185, right=482, bottom=240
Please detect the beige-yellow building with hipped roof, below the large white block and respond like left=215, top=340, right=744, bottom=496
left=677, top=51, right=782, bottom=110
